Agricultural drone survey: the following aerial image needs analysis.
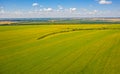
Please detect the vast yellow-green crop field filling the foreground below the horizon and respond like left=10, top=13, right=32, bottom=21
left=0, top=24, right=120, bottom=74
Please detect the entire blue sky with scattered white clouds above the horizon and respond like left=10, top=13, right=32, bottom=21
left=0, top=0, right=120, bottom=18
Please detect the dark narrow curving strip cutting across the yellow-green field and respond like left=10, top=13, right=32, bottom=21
left=37, top=27, right=120, bottom=40
